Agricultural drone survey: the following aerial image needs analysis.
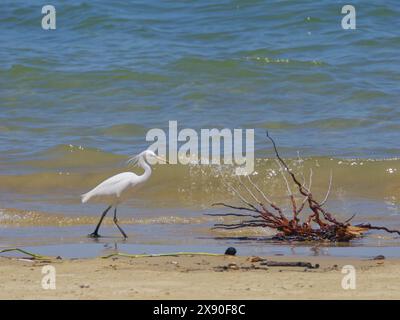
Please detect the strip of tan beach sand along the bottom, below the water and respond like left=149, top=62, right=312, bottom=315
left=0, top=256, right=400, bottom=299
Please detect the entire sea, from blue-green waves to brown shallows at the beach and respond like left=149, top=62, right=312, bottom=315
left=0, top=0, right=400, bottom=252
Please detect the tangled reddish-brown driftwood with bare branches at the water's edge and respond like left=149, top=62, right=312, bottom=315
left=209, top=131, right=400, bottom=241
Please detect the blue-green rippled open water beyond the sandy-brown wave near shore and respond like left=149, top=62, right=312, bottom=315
left=0, top=0, right=400, bottom=160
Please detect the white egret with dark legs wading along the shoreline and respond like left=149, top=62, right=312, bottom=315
left=81, top=150, right=168, bottom=238
